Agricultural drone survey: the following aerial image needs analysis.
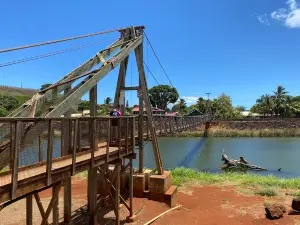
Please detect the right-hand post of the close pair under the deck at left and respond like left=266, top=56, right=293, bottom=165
left=64, top=177, right=72, bottom=224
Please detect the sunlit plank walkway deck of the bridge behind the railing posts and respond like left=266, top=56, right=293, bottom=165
left=0, top=143, right=132, bottom=203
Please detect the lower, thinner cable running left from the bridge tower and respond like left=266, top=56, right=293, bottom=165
left=0, top=41, right=110, bottom=67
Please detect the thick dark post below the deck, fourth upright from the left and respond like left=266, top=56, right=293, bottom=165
left=88, top=167, right=98, bottom=225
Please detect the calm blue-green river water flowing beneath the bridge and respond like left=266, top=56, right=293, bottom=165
left=20, top=137, right=300, bottom=177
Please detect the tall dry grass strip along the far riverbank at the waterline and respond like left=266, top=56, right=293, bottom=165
left=172, top=128, right=300, bottom=137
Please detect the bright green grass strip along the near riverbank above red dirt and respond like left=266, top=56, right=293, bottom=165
left=172, top=167, right=300, bottom=189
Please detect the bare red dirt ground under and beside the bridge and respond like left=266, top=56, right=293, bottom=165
left=0, top=178, right=300, bottom=225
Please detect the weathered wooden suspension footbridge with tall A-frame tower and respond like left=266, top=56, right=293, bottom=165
left=0, top=26, right=210, bottom=224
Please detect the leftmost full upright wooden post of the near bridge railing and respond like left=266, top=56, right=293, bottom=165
left=11, top=121, right=21, bottom=200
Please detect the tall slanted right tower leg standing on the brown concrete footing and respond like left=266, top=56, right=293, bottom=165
left=135, top=44, right=163, bottom=175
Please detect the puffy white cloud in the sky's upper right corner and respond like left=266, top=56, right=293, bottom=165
left=271, top=0, right=300, bottom=28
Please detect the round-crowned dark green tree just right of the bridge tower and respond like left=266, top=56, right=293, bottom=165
left=149, top=85, right=179, bottom=110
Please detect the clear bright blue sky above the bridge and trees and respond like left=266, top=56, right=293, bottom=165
left=0, top=0, right=300, bottom=107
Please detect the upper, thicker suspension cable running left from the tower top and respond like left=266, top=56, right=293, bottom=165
left=0, top=28, right=124, bottom=53
